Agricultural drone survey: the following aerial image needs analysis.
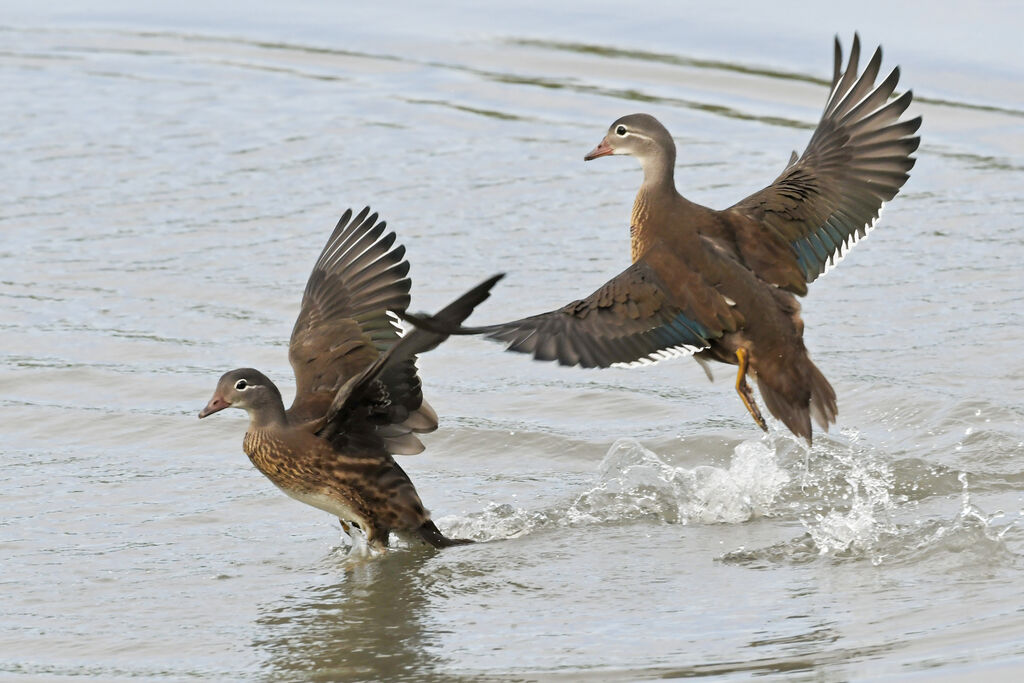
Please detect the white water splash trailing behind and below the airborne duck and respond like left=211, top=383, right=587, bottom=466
left=438, top=431, right=1018, bottom=566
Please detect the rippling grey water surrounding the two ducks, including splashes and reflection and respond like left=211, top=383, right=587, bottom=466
left=0, top=0, right=1024, bottom=681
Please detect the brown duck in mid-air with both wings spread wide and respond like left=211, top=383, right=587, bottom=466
left=476, top=36, right=921, bottom=442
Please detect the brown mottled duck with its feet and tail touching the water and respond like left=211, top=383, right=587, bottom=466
left=199, top=208, right=502, bottom=549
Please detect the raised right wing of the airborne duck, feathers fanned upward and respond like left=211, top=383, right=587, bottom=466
left=730, top=35, right=921, bottom=294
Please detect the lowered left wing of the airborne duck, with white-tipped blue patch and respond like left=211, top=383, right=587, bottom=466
left=473, top=261, right=722, bottom=368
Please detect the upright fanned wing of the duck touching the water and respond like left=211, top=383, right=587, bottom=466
left=288, top=208, right=437, bottom=453
